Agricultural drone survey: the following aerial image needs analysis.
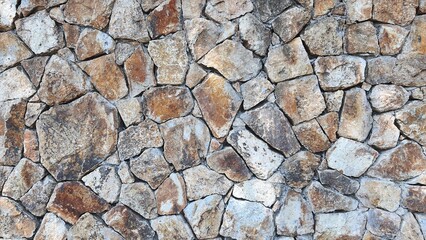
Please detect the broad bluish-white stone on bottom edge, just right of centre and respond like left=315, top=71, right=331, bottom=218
left=220, top=198, right=275, bottom=239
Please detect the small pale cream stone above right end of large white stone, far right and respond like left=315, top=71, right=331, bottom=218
left=368, top=113, right=399, bottom=149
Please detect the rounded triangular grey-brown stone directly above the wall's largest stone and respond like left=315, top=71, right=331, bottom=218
left=38, top=55, right=91, bottom=105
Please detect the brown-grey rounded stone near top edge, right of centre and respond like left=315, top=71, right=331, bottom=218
left=272, top=7, right=311, bottom=43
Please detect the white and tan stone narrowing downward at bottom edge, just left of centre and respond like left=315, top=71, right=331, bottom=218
left=184, top=195, right=225, bottom=239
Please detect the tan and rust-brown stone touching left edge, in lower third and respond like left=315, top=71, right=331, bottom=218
left=2, top=158, right=45, bottom=200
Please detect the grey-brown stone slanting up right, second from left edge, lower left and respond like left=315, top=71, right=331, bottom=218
left=20, top=176, right=56, bottom=217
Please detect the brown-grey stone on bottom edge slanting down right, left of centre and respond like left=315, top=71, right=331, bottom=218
left=102, top=204, right=155, bottom=240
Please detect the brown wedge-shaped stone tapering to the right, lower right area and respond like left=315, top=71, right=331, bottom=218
left=305, top=181, right=358, bottom=213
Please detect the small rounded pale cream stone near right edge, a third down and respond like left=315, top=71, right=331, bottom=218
left=370, top=84, right=410, bottom=112
